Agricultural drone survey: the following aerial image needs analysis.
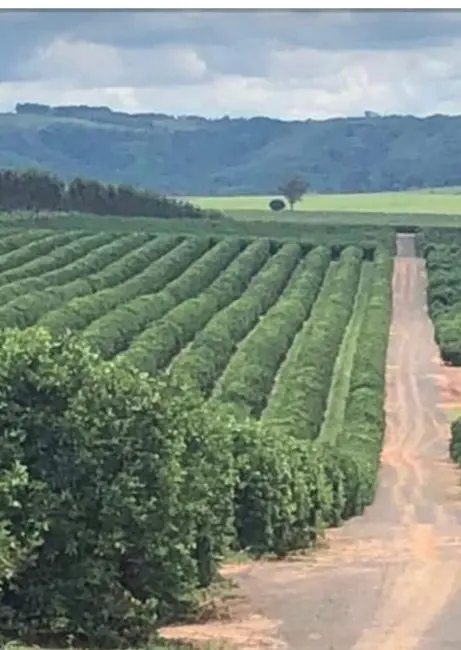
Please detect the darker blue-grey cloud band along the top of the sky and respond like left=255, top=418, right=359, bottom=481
left=0, top=10, right=461, bottom=50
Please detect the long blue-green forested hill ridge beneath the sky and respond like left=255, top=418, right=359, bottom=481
left=0, top=104, right=461, bottom=195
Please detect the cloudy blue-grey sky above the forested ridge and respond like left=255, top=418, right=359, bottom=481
left=0, top=10, right=461, bottom=119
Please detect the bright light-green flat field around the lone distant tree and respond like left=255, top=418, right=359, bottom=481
left=188, top=189, right=461, bottom=218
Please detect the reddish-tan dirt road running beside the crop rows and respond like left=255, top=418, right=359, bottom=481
left=160, top=236, right=461, bottom=650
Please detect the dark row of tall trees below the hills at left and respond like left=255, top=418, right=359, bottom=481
left=0, top=169, right=220, bottom=219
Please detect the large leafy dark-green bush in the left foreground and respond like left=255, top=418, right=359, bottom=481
left=0, top=328, right=235, bottom=646
